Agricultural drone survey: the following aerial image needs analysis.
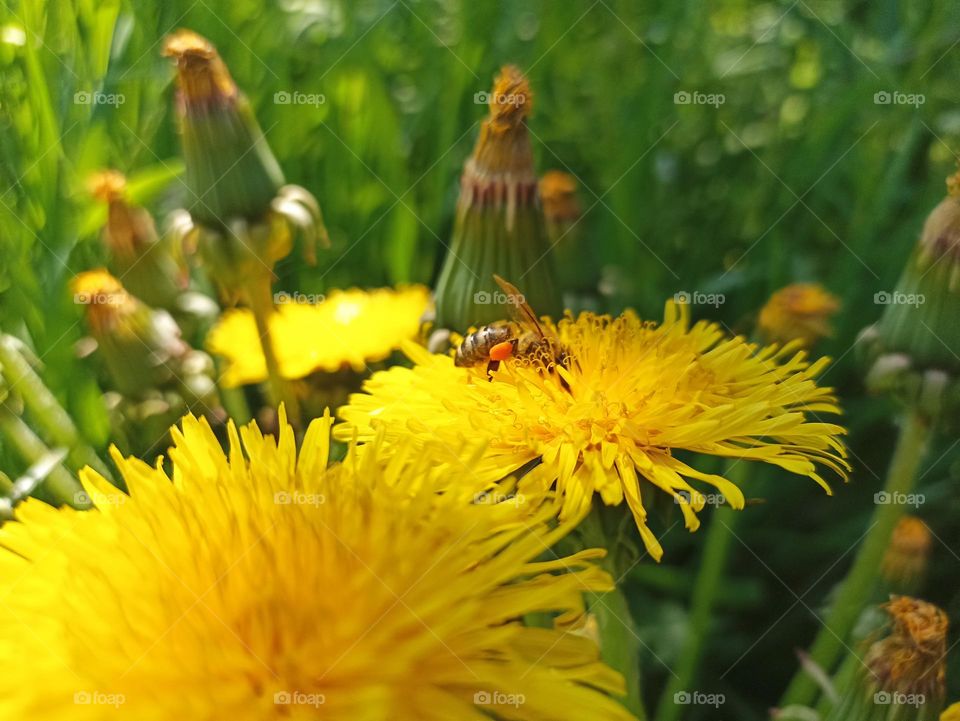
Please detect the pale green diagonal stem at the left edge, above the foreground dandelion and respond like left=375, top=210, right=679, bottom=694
left=0, top=335, right=113, bottom=479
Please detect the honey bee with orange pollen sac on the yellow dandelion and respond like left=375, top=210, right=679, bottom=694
left=453, top=275, right=569, bottom=374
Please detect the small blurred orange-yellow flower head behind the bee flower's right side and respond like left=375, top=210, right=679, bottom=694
left=757, top=283, right=840, bottom=346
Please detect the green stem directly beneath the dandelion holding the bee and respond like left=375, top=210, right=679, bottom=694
left=577, top=505, right=647, bottom=721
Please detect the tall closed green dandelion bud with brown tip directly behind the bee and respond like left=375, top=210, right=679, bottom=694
left=436, top=65, right=562, bottom=330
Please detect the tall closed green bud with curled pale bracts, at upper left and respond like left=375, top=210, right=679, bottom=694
left=164, top=30, right=329, bottom=302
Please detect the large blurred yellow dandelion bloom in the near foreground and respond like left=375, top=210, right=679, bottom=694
left=0, top=413, right=632, bottom=721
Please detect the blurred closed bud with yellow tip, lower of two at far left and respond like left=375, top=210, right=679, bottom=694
left=72, top=269, right=188, bottom=398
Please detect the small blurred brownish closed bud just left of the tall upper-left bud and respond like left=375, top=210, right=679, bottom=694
left=89, top=170, right=186, bottom=309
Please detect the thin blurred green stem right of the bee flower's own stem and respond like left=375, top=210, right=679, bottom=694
left=656, top=498, right=746, bottom=721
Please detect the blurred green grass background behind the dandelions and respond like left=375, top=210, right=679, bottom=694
left=0, top=0, right=960, bottom=720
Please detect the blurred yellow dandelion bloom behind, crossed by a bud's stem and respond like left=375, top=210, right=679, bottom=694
left=207, top=285, right=430, bottom=388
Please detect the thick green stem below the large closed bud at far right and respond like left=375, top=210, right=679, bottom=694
left=780, top=409, right=930, bottom=707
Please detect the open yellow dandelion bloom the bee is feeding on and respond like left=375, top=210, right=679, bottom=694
left=335, top=304, right=848, bottom=559
